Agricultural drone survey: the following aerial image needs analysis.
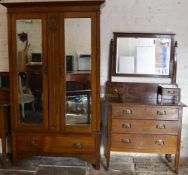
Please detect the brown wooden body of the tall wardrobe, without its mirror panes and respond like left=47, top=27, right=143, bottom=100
left=1, top=0, right=104, bottom=169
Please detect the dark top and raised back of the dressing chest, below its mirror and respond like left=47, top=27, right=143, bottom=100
left=105, top=82, right=186, bottom=109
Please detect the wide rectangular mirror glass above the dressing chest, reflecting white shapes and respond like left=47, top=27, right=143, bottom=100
left=114, top=35, right=173, bottom=76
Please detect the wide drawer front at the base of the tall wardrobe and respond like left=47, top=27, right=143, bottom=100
left=16, top=135, right=96, bottom=153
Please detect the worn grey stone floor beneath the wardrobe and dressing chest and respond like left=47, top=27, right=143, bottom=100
left=0, top=125, right=188, bottom=175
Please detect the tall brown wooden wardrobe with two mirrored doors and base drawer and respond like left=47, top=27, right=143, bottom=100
left=1, top=0, right=104, bottom=169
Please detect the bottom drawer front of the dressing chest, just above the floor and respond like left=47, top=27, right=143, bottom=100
left=111, top=134, right=177, bottom=153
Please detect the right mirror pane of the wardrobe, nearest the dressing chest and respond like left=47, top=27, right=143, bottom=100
left=65, top=18, right=91, bottom=125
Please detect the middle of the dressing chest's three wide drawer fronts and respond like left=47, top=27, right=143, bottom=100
left=112, top=118, right=178, bottom=135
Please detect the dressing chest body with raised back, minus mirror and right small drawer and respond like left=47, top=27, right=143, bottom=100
left=105, top=82, right=186, bottom=172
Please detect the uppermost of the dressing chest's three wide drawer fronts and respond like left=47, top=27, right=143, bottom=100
left=112, top=105, right=178, bottom=120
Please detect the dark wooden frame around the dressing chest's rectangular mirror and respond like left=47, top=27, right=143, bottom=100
left=110, top=32, right=176, bottom=79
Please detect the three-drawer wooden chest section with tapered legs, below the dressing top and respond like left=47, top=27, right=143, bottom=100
left=106, top=101, right=185, bottom=172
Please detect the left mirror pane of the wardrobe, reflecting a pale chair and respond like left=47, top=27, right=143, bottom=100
left=16, top=19, right=43, bottom=124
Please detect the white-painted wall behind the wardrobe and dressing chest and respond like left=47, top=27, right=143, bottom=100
left=0, top=0, right=188, bottom=119
